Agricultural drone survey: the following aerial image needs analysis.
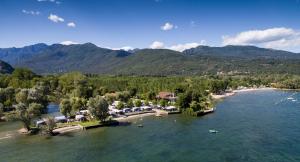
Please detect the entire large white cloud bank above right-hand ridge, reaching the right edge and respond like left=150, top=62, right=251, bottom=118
left=222, top=27, right=300, bottom=50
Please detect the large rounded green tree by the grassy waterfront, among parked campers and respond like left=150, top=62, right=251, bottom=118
left=87, top=96, right=109, bottom=122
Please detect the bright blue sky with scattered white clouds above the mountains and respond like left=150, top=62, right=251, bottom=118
left=0, top=0, right=300, bottom=52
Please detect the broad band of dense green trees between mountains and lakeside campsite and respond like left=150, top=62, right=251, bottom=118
left=0, top=69, right=300, bottom=129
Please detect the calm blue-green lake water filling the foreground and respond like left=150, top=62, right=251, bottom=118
left=0, top=90, right=300, bottom=162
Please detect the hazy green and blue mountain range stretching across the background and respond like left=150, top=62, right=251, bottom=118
left=0, top=43, right=300, bottom=75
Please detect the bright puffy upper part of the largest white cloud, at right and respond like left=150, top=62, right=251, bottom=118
left=223, top=28, right=296, bottom=45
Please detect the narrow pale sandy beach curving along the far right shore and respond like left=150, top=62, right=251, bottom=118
left=211, top=87, right=278, bottom=100
